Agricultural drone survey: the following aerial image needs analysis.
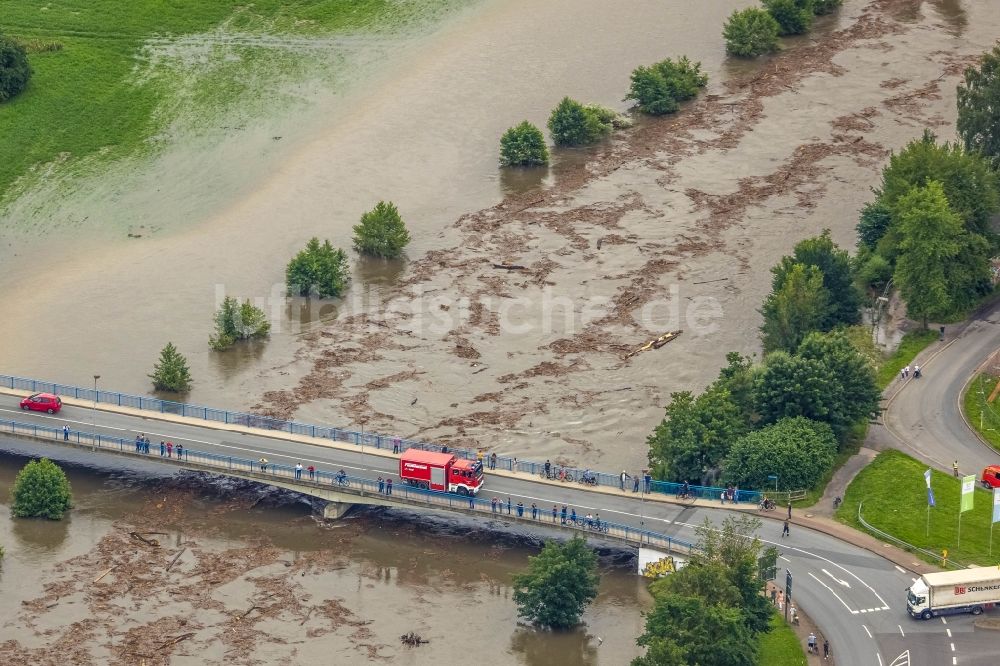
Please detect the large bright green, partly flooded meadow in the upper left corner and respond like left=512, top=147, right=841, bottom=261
left=0, top=0, right=461, bottom=200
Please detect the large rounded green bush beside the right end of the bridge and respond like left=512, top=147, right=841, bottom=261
left=725, top=416, right=837, bottom=490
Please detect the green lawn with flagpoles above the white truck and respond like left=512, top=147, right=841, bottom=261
left=837, top=451, right=1000, bottom=566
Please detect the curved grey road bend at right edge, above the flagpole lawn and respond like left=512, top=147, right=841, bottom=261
left=884, top=306, right=1000, bottom=476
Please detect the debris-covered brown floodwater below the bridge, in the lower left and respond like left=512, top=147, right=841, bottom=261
left=0, top=443, right=649, bottom=666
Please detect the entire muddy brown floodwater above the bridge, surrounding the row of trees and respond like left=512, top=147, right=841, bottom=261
left=0, top=0, right=1000, bottom=470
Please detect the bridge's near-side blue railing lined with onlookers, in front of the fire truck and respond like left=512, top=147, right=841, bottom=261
left=0, top=419, right=697, bottom=555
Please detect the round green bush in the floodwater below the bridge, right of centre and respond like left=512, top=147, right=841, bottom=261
left=514, top=537, right=600, bottom=629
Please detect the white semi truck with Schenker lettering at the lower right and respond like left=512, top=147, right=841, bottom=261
left=906, top=567, right=1000, bottom=620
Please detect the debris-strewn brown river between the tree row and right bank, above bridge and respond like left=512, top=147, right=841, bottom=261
left=257, top=0, right=998, bottom=469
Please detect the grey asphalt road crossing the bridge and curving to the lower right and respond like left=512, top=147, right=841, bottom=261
left=0, top=395, right=984, bottom=666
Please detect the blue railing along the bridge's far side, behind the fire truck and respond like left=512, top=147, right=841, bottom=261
left=0, top=375, right=762, bottom=504
